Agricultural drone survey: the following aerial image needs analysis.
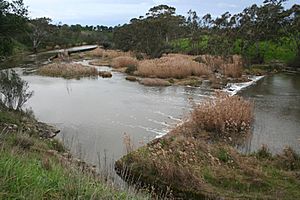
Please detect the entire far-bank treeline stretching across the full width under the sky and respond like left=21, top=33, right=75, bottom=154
left=0, top=0, right=300, bottom=66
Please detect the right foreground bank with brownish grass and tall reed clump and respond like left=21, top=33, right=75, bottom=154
left=116, top=96, right=300, bottom=199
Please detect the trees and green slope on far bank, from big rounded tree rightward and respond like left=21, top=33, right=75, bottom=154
left=113, top=0, right=300, bottom=65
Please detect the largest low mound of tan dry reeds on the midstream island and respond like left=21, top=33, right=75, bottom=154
left=137, top=56, right=211, bottom=79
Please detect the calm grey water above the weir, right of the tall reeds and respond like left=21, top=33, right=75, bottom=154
left=241, top=73, right=300, bottom=153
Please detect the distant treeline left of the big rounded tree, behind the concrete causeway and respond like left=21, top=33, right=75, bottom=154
left=0, top=0, right=113, bottom=58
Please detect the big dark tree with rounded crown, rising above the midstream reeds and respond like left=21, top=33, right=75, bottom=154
left=113, top=5, right=185, bottom=57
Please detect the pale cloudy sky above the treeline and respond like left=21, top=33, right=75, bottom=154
left=24, top=0, right=299, bottom=26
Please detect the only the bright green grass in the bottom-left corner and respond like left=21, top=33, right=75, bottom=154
left=0, top=152, right=134, bottom=199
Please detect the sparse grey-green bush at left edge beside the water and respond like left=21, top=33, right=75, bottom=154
left=0, top=70, right=33, bottom=110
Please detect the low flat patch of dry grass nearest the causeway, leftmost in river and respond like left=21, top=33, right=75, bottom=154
left=38, top=63, right=98, bottom=78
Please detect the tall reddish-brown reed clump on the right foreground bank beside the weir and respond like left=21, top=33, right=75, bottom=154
left=192, top=93, right=253, bottom=137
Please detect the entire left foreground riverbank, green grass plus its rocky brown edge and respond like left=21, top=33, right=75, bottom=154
left=0, top=107, right=148, bottom=199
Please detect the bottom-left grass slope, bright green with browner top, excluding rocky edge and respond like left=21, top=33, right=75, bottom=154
left=0, top=134, right=146, bottom=200
